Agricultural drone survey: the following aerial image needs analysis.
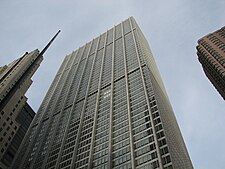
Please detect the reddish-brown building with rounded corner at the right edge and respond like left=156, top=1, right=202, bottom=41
left=197, top=27, right=225, bottom=100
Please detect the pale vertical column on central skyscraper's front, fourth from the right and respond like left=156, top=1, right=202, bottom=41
left=88, top=31, right=108, bottom=169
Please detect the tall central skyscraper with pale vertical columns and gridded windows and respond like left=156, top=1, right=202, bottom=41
left=13, top=17, right=193, bottom=169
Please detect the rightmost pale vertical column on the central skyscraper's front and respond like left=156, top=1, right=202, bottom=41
left=129, top=18, right=163, bottom=169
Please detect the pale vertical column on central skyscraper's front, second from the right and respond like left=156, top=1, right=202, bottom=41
left=121, top=22, right=135, bottom=169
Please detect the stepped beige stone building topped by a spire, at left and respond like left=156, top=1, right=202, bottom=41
left=0, top=30, right=60, bottom=169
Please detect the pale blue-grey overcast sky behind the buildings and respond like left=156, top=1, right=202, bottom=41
left=0, top=0, right=225, bottom=169
